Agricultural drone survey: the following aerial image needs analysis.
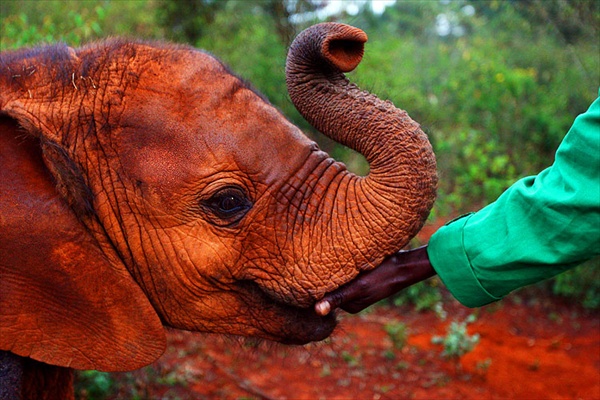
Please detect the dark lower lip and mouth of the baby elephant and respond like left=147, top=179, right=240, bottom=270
left=237, top=281, right=337, bottom=345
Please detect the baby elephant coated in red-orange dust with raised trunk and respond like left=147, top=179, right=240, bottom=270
left=0, top=23, right=437, bottom=398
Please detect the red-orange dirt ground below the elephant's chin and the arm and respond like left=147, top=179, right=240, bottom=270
left=102, top=293, right=600, bottom=399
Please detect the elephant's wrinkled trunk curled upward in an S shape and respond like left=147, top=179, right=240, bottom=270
left=286, top=23, right=437, bottom=276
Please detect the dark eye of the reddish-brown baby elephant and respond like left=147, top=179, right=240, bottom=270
left=202, top=186, right=252, bottom=225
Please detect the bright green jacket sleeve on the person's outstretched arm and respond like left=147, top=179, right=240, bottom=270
left=427, top=97, right=600, bottom=307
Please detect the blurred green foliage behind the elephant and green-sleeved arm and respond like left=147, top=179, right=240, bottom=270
left=0, top=0, right=600, bottom=304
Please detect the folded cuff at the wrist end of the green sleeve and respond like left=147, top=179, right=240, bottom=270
left=427, top=214, right=500, bottom=307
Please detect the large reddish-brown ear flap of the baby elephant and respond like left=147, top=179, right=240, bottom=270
left=0, top=102, right=165, bottom=371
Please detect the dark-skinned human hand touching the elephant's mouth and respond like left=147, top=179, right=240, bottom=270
left=315, top=246, right=436, bottom=316
